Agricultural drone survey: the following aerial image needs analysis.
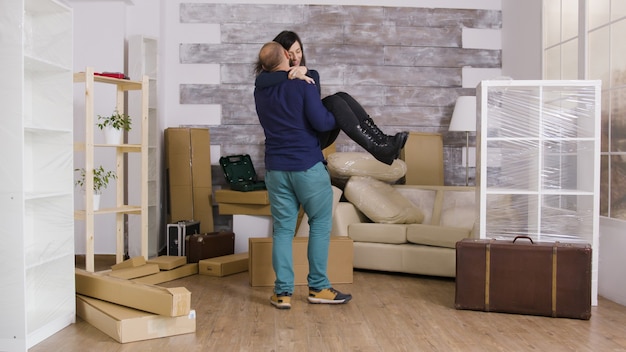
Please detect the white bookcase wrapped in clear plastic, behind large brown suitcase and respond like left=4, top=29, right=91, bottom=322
left=476, top=80, right=601, bottom=305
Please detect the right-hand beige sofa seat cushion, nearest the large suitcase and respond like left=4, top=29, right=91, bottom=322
left=406, top=224, right=471, bottom=248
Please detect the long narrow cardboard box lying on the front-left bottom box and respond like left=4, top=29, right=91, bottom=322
left=74, top=269, right=191, bottom=317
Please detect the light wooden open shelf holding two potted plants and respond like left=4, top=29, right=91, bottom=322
left=74, top=67, right=149, bottom=271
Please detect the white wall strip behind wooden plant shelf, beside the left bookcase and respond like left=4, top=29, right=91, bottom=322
left=69, top=0, right=126, bottom=254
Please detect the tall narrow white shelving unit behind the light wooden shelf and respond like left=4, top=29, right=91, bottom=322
left=127, top=35, right=158, bottom=257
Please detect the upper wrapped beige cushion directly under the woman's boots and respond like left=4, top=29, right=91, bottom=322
left=327, top=152, right=406, bottom=183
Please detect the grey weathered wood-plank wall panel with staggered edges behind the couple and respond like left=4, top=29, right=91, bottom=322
left=179, top=2, right=502, bottom=184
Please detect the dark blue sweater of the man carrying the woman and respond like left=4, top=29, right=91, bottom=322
left=254, top=71, right=336, bottom=171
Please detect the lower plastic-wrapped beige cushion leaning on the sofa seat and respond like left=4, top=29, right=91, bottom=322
left=344, top=176, right=424, bottom=224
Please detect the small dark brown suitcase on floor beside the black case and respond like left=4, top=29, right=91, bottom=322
left=185, top=231, right=235, bottom=263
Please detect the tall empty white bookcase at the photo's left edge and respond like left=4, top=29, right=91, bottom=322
left=0, top=0, right=76, bottom=351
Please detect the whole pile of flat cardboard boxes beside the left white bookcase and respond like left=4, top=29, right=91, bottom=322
left=75, top=257, right=198, bottom=343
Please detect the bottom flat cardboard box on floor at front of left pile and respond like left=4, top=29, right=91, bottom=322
left=76, top=295, right=196, bottom=343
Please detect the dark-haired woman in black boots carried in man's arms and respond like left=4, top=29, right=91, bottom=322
left=255, top=31, right=408, bottom=165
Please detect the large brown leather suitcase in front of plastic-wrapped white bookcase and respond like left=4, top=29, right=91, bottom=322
left=455, top=236, right=591, bottom=319
